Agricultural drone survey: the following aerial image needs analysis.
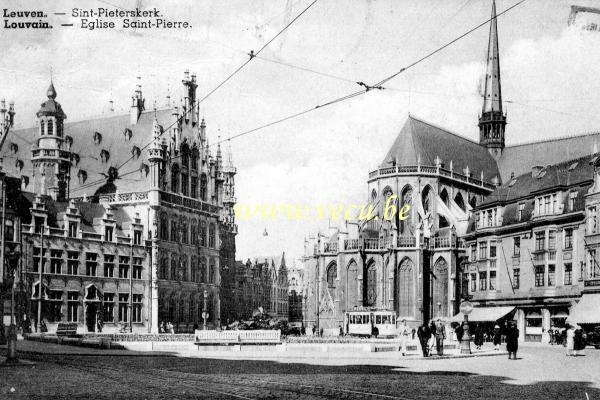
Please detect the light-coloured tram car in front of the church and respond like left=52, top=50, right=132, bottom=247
left=344, top=310, right=397, bottom=337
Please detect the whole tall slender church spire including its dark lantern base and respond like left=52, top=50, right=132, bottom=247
left=479, top=1, right=506, bottom=158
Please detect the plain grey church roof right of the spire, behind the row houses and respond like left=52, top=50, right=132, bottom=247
left=498, top=133, right=600, bottom=182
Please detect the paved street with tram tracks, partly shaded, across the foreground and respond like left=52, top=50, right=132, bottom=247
left=0, top=346, right=600, bottom=399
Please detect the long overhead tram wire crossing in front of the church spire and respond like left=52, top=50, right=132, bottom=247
left=203, top=0, right=527, bottom=146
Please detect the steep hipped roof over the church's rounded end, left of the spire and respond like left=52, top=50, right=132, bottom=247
left=380, top=115, right=499, bottom=182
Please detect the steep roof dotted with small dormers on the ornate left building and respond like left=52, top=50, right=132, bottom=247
left=0, top=107, right=203, bottom=197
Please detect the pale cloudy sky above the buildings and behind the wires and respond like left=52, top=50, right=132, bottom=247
left=0, top=0, right=600, bottom=259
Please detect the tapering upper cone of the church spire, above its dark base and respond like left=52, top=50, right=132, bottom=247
left=481, top=1, right=502, bottom=114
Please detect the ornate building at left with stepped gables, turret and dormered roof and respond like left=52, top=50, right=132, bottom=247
left=0, top=71, right=237, bottom=333
